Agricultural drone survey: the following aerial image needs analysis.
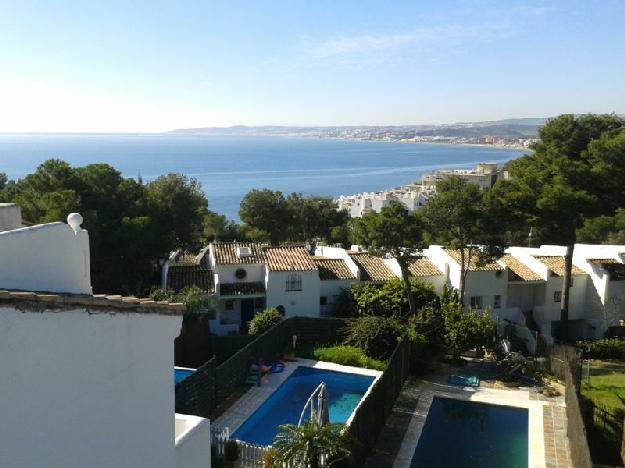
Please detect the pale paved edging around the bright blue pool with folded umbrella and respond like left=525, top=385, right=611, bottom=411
left=213, top=359, right=382, bottom=442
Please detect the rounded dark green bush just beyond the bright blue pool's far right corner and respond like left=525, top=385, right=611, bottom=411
left=345, top=316, right=407, bottom=359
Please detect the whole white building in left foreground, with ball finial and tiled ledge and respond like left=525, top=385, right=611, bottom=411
left=0, top=208, right=211, bottom=468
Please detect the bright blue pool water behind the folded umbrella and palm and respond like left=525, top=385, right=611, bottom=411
left=232, top=366, right=374, bottom=445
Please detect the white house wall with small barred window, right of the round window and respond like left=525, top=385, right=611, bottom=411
left=267, top=270, right=321, bottom=317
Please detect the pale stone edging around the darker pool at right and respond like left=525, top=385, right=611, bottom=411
left=393, top=380, right=548, bottom=468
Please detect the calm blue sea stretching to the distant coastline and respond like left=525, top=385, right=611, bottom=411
left=0, top=134, right=522, bottom=219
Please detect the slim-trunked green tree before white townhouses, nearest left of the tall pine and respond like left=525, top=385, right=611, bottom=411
left=421, top=176, right=485, bottom=302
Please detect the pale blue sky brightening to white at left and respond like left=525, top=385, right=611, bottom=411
left=0, top=0, right=625, bottom=133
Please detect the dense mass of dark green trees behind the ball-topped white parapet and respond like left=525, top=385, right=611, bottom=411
left=0, top=159, right=207, bottom=294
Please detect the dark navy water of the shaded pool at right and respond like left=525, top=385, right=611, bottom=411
left=410, top=397, right=528, bottom=468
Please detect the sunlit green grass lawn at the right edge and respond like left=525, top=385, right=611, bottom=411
left=582, top=359, right=625, bottom=409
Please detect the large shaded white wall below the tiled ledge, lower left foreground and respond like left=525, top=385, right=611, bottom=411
left=0, top=304, right=185, bottom=468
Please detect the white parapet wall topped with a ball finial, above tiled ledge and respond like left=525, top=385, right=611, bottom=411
left=0, top=214, right=92, bottom=294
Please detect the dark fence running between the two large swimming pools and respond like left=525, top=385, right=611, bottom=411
left=350, top=339, right=412, bottom=466
